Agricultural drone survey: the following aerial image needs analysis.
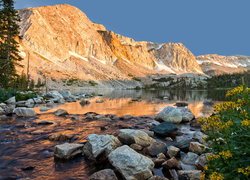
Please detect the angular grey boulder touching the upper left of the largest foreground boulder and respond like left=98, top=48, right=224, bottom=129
left=83, top=134, right=121, bottom=160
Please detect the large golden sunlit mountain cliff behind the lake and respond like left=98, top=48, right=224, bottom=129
left=19, top=4, right=203, bottom=87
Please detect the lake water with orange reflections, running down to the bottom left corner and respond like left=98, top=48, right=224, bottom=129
left=0, top=90, right=227, bottom=179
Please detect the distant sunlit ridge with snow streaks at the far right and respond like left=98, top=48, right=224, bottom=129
left=196, top=54, right=250, bottom=76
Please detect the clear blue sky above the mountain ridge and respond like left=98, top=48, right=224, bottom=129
left=16, top=0, right=250, bottom=55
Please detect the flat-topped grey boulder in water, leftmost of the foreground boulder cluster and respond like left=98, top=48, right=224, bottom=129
left=54, top=143, right=83, bottom=159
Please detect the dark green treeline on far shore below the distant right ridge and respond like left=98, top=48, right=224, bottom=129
left=207, top=70, right=250, bottom=89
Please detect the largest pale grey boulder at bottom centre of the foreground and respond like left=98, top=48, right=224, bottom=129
left=108, top=145, right=154, bottom=180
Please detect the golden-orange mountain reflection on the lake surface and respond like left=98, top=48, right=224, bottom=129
left=35, top=97, right=212, bottom=117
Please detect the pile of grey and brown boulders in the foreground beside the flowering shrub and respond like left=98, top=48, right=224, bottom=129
left=54, top=118, right=207, bottom=180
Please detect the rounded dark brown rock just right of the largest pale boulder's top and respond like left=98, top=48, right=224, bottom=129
left=146, top=141, right=167, bottom=156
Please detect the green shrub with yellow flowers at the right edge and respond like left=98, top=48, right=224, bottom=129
left=199, top=86, right=250, bottom=180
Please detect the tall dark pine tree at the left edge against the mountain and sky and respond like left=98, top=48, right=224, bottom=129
left=0, top=0, right=22, bottom=88
